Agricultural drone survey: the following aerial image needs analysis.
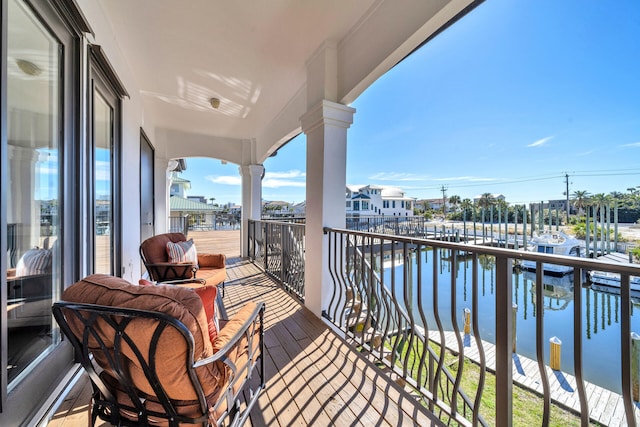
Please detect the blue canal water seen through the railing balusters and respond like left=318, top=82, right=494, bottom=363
left=383, top=249, right=640, bottom=393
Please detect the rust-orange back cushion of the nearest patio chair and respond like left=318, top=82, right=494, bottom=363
left=62, top=274, right=225, bottom=400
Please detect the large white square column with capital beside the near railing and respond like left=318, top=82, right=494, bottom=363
left=300, top=100, right=355, bottom=316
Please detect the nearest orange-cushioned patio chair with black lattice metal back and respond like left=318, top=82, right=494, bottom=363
left=53, top=274, right=264, bottom=426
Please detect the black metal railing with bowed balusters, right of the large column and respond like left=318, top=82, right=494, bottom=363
left=325, top=228, right=640, bottom=426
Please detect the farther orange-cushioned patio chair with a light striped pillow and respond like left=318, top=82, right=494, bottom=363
left=140, top=233, right=227, bottom=296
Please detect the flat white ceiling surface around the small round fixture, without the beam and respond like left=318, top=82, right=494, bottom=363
left=101, top=0, right=373, bottom=139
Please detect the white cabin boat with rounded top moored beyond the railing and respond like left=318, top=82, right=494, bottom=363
left=522, top=231, right=582, bottom=275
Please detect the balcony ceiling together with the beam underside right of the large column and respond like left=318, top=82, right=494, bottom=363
left=96, top=0, right=472, bottom=157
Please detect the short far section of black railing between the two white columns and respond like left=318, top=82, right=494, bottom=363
left=248, top=220, right=305, bottom=302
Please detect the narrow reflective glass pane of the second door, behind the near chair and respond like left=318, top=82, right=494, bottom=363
left=93, top=91, right=114, bottom=274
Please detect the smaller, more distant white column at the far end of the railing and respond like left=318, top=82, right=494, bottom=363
left=239, top=165, right=264, bottom=257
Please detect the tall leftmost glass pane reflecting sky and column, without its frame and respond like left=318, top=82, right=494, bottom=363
left=3, top=0, right=62, bottom=389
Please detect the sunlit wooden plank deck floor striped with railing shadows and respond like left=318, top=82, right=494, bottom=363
left=49, top=258, right=438, bottom=427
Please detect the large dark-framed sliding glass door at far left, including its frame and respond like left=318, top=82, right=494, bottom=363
left=0, top=0, right=81, bottom=425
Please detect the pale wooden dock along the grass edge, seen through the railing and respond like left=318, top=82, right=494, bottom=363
left=429, top=331, right=640, bottom=427
